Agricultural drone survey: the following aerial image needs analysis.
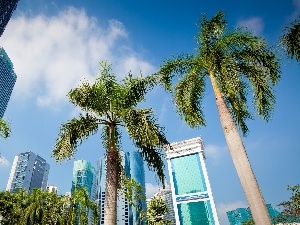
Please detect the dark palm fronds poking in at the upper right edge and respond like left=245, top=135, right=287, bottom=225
left=280, top=17, right=300, bottom=62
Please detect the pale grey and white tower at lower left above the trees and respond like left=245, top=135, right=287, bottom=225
left=6, top=152, right=50, bottom=192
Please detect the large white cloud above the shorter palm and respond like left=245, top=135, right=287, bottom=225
left=1, top=7, right=153, bottom=106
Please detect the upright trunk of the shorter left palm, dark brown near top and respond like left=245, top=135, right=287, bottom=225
left=104, top=124, right=118, bottom=225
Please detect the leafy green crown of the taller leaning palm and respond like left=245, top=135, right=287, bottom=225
left=159, top=12, right=280, bottom=135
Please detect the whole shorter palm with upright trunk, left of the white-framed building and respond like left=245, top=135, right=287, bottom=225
left=52, top=62, right=168, bottom=225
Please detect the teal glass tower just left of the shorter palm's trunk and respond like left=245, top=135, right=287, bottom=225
left=71, top=160, right=96, bottom=224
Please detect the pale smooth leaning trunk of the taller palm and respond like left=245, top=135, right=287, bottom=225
left=210, top=73, right=272, bottom=225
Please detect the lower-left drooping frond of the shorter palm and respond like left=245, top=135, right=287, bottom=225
left=52, top=114, right=98, bottom=161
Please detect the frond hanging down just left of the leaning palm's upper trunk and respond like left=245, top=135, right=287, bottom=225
left=174, top=67, right=206, bottom=128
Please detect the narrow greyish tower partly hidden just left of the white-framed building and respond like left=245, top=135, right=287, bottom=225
left=154, top=186, right=176, bottom=225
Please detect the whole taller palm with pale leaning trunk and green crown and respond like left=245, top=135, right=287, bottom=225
left=158, top=12, right=280, bottom=225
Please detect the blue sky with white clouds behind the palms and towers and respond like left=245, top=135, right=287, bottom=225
left=0, top=0, right=300, bottom=224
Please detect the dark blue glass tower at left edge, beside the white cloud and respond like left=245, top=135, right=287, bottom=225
left=0, top=47, right=17, bottom=118
